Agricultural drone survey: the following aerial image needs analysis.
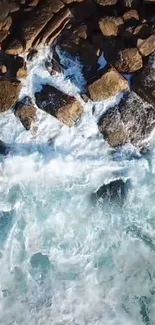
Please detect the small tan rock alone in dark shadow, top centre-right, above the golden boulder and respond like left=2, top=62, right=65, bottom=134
left=99, top=17, right=123, bottom=36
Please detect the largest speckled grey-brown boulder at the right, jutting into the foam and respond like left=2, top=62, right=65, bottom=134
left=98, top=92, right=155, bottom=148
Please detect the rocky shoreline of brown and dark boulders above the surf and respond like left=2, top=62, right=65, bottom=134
left=0, top=0, right=155, bottom=148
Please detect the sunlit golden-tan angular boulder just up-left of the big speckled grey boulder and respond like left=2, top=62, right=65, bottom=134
left=88, top=66, right=129, bottom=101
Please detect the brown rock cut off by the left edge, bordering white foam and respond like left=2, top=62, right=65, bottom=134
left=0, top=80, right=21, bottom=112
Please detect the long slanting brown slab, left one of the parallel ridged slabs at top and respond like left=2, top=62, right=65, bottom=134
left=21, top=0, right=64, bottom=51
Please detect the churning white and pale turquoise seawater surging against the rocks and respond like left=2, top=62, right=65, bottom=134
left=0, top=49, right=155, bottom=325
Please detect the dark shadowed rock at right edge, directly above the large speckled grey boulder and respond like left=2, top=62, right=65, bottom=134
left=132, top=53, right=155, bottom=107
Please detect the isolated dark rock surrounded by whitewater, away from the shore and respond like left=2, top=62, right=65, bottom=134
left=92, top=179, right=131, bottom=203
